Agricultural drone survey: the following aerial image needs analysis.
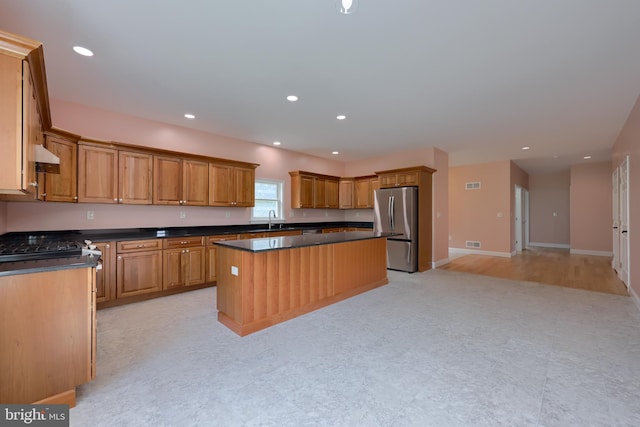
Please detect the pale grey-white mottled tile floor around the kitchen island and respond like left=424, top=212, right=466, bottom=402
left=71, top=270, right=640, bottom=426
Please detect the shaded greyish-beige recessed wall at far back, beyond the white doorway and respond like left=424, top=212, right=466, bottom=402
left=529, top=170, right=571, bottom=244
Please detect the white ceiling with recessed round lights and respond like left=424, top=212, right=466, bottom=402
left=0, top=0, right=640, bottom=173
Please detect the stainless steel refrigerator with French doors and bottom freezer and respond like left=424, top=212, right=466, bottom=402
left=373, top=187, right=418, bottom=273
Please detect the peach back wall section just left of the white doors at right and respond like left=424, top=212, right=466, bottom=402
left=570, top=162, right=612, bottom=255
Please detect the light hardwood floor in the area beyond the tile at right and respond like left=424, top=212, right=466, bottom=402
left=438, top=248, right=629, bottom=295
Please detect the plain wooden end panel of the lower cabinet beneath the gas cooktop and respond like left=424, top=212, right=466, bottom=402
left=0, top=267, right=96, bottom=406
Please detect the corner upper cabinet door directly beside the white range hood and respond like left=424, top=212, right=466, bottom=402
left=42, top=136, right=78, bottom=203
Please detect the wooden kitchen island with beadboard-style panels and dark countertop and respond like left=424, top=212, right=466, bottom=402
left=217, top=231, right=388, bottom=336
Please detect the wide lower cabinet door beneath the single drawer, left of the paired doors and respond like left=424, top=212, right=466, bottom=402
left=116, top=251, right=162, bottom=298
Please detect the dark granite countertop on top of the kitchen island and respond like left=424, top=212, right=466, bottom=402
left=216, top=231, right=394, bottom=252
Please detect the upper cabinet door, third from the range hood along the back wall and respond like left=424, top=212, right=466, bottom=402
left=118, top=151, right=153, bottom=205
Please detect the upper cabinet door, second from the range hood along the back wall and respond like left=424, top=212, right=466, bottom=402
left=78, top=145, right=118, bottom=203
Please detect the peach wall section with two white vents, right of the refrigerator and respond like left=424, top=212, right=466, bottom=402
left=449, top=160, right=513, bottom=255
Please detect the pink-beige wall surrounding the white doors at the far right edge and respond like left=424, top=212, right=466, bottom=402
left=611, top=97, right=640, bottom=295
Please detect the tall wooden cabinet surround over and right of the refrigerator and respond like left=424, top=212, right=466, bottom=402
left=376, top=166, right=436, bottom=271
